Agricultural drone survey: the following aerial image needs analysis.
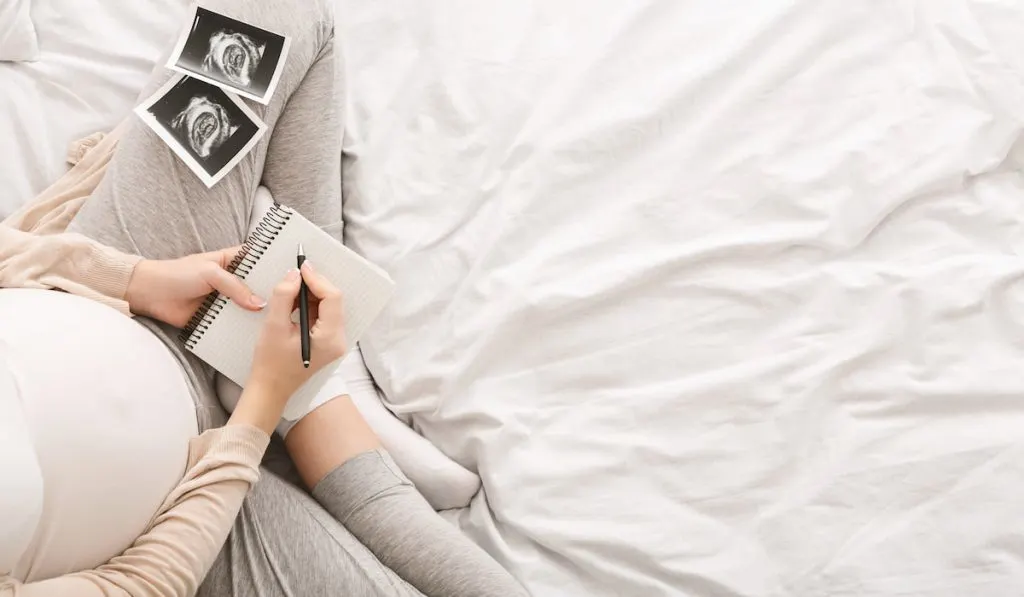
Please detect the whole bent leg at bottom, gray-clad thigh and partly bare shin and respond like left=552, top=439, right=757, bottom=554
left=197, top=396, right=526, bottom=597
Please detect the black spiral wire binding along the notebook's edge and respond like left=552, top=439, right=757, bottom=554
left=178, top=202, right=295, bottom=350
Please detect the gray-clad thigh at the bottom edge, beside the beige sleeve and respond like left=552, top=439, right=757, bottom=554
left=198, top=469, right=422, bottom=597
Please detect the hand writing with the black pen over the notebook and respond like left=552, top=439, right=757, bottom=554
left=231, top=261, right=346, bottom=433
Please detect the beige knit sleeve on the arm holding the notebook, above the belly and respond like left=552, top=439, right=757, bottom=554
left=0, top=224, right=141, bottom=314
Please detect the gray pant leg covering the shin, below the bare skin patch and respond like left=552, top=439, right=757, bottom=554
left=312, top=450, right=526, bottom=597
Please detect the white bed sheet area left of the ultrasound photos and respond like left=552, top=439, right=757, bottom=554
left=0, top=0, right=188, bottom=218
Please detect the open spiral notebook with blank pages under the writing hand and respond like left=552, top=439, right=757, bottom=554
left=181, top=196, right=394, bottom=420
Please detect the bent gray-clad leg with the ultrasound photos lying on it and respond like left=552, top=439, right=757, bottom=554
left=70, top=0, right=341, bottom=259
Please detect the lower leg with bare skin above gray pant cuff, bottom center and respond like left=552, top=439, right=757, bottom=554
left=286, top=396, right=526, bottom=597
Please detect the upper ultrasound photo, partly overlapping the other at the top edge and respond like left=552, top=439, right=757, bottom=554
left=167, top=5, right=291, bottom=103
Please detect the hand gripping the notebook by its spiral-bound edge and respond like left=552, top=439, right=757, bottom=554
left=125, top=247, right=266, bottom=328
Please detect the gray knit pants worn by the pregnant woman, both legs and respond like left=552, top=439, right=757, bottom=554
left=71, top=0, right=525, bottom=597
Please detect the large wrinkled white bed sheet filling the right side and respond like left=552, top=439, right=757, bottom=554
left=338, top=0, right=1024, bottom=597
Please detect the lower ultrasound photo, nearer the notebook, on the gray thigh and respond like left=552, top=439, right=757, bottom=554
left=135, top=76, right=266, bottom=186
